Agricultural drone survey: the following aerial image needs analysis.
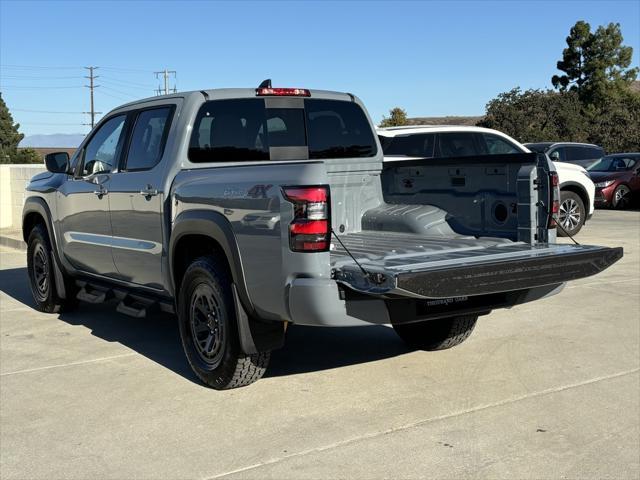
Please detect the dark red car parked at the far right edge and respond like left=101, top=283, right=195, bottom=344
left=587, top=153, right=640, bottom=208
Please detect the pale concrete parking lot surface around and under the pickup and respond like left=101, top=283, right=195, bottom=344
left=0, top=211, right=640, bottom=480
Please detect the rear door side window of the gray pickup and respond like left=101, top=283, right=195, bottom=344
left=125, top=107, right=172, bottom=170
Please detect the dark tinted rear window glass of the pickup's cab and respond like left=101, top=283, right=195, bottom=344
left=189, top=98, right=377, bottom=162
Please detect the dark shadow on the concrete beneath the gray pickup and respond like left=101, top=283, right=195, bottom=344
left=0, top=268, right=409, bottom=384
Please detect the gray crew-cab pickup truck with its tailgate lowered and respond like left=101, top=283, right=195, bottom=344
left=23, top=82, right=622, bottom=389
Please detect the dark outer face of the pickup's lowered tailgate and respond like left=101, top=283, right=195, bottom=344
left=397, top=247, right=623, bottom=299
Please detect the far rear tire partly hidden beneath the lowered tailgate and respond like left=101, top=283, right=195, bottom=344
left=393, top=315, right=478, bottom=351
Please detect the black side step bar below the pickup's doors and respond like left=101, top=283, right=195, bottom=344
left=76, top=280, right=175, bottom=318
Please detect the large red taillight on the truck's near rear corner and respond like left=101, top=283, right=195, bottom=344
left=282, top=185, right=331, bottom=252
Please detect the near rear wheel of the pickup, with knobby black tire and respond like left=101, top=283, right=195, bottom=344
left=178, top=256, right=271, bottom=390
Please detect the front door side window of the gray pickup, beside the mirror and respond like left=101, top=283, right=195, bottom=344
left=81, top=115, right=127, bottom=176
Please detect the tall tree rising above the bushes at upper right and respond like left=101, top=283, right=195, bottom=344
left=551, top=20, right=638, bottom=104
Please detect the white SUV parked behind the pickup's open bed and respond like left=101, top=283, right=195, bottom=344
left=378, top=125, right=595, bottom=236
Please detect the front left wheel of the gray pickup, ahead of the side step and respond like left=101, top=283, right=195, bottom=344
left=27, top=224, right=78, bottom=313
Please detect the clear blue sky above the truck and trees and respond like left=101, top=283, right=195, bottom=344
left=0, top=0, right=640, bottom=135
